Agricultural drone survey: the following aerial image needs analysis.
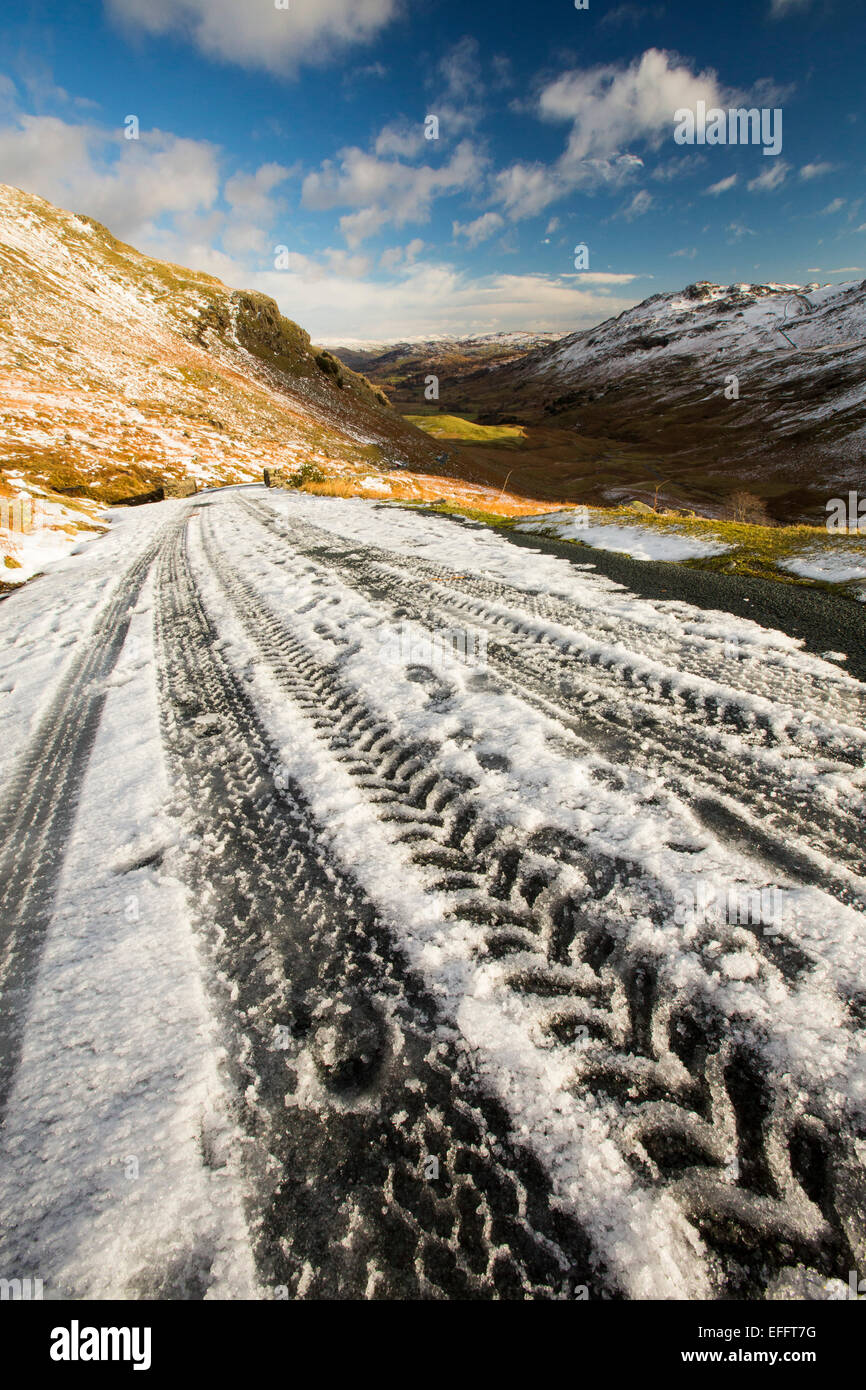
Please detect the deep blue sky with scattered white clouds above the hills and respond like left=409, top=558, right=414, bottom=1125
left=0, top=0, right=866, bottom=342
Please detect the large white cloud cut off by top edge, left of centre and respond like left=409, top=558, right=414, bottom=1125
left=106, top=0, right=398, bottom=76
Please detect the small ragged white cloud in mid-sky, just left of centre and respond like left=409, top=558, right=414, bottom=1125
left=302, top=140, right=484, bottom=246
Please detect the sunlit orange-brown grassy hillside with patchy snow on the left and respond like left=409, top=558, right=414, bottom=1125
left=0, top=188, right=441, bottom=514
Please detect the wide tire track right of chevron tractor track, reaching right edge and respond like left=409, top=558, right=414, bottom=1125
left=239, top=499, right=866, bottom=908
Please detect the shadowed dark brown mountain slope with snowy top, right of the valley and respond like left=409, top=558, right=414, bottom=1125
left=405, top=281, right=866, bottom=521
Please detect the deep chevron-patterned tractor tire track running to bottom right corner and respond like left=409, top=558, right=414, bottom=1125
left=195, top=500, right=859, bottom=1295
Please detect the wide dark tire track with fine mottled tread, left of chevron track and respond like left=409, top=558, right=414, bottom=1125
left=156, top=514, right=588, bottom=1298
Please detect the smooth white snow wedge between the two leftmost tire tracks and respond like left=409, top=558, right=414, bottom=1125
left=0, top=571, right=260, bottom=1300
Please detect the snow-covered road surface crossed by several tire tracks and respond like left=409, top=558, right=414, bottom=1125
left=0, top=488, right=866, bottom=1298
